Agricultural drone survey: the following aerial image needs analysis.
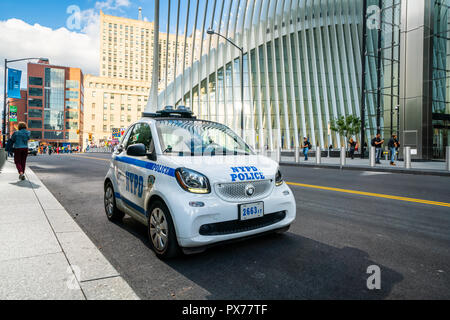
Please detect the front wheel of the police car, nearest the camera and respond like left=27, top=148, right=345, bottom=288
left=147, top=201, right=180, bottom=259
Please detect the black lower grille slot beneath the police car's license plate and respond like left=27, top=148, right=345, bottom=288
left=199, top=211, right=286, bottom=236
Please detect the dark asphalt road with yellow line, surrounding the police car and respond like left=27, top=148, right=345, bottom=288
left=28, top=154, right=450, bottom=299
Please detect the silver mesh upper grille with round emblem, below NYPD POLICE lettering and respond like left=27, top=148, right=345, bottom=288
left=215, top=179, right=274, bottom=202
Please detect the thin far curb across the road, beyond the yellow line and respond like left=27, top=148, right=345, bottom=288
left=280, top=162, right=450, bottom=177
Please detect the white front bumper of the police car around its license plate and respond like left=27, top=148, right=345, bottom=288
left=169, top=183, right=296, bottom=248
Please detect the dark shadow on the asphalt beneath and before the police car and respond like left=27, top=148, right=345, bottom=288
left=117, top=217, right=403, bottom=300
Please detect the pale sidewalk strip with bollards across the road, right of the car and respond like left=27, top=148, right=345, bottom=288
left=280, top=155, right=450, bottom=176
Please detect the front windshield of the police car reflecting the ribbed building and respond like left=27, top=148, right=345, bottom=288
left=156, top=119, right=254, bottom=156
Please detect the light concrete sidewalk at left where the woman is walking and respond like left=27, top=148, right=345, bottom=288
left=0, top=160, right=138, bottom=300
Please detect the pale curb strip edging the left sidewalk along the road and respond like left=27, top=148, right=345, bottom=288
left=5, top=160, right=139, bottom=300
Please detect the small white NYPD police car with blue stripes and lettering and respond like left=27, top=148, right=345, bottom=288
left=104, top=107, right=296, bottom=258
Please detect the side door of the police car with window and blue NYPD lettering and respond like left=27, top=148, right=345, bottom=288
left=121, top=122, right=153, bottom=216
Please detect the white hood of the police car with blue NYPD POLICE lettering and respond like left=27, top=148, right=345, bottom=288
left=158, top=155, right=278, bottom=184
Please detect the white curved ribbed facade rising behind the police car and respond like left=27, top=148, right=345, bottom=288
left=154, top=0, right=377, bottom=150
